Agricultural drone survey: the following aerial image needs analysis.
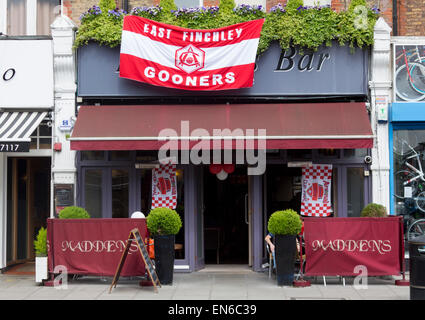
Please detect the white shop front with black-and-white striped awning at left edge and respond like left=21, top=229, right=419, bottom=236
left=0, top=36, right=54, bottom=269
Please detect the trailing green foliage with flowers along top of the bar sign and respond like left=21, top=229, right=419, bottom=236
left=74, top=0, right=379, bottom=54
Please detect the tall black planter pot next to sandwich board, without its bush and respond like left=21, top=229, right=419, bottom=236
left=153, top=235, right=175, bottom=284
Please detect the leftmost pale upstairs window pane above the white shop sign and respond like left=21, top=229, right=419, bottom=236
left=7, top=0, right=27, bottom=36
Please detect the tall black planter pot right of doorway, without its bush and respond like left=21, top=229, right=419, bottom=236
left=275, top=235, right=297, bottom=286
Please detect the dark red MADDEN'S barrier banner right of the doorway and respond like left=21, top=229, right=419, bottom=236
left=304, top=217, right=404, bottom=276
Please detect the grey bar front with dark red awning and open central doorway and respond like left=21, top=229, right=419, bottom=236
left=70, top=35, right=373, bottom=272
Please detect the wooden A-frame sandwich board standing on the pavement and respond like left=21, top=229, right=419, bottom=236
left=109, top=228, right=161, bottom=293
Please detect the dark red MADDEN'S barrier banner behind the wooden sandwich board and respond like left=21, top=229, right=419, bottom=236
left=47, top=218, right=148, bottom=277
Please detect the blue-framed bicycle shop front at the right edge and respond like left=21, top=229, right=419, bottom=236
left=389, top=37, right=425, bottom=245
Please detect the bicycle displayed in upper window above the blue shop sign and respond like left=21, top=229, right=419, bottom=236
left=394, top=46, right=425, bottom=101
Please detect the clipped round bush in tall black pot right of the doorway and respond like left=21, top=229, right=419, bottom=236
left=268, top=209, right=302, bottom=286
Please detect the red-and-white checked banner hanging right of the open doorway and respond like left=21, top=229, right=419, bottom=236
left=301, top=164, right=332, bottom=217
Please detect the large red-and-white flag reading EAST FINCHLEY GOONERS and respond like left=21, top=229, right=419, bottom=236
left=120, top=16, right=264, bottom=90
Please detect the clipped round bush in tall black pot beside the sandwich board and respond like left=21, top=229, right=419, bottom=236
left=146, top=208, right=182, bottom=284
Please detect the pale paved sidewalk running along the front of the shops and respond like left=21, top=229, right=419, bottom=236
left=0, top=270, right=409, bottom=301
